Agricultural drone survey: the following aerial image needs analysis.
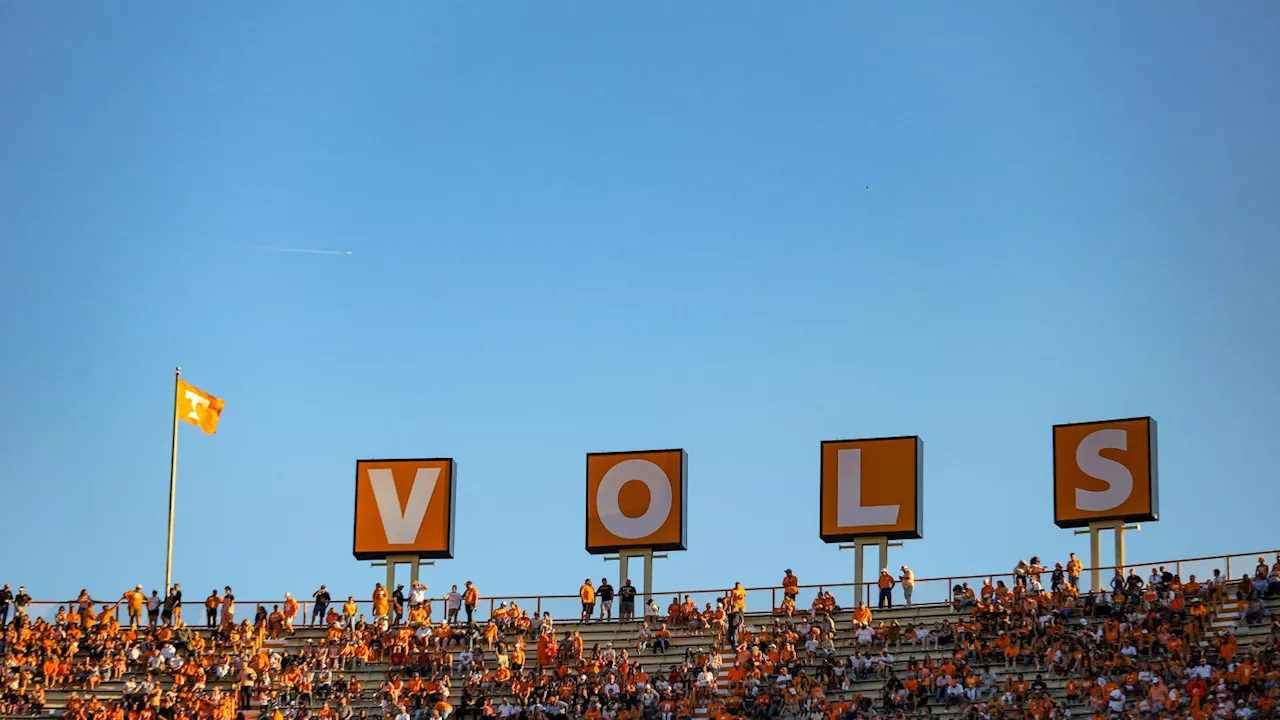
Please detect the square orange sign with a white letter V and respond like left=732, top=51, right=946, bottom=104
left=352, top=457, right=458, bottom=560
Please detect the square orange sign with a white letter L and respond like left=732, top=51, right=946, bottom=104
left=818, top=436, right=924, bottom=542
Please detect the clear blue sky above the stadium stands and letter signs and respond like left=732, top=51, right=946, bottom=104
left=0, top=0, right=1280, bottom=609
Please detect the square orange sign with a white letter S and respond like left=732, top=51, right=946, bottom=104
left=1053, top=418, right=1160, bottom=528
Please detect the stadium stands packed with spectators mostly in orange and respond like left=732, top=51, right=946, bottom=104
left=0, top=555, right=1280, bottom=720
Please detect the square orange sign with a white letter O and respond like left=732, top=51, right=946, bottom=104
left=586, top=450, right=689, bottom=555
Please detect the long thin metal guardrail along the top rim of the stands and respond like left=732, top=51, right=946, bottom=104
left=10, top=550, right=1280, bottom=626
